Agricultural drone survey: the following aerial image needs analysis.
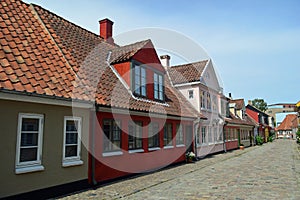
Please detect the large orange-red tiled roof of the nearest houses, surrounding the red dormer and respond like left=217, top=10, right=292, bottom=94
left=0, top=0, right=203, bottom=117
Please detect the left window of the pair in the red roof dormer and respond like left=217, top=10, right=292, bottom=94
left=132, top=63, right=147, bottom=97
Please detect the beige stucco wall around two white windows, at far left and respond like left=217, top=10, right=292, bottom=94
left=0, top=100, right=89, bottom=198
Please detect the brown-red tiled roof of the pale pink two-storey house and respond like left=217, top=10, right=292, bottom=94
left=168, top=60, right=208, bottom=85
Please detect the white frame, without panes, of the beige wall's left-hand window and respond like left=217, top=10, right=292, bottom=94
left=15, top=113, right=44, bottom=174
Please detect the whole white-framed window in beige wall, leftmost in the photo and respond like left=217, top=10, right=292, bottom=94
left=15, top=113, right=44, bottom=174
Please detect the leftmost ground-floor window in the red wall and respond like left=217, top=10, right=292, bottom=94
left=103, top=119, right=121, bottom=152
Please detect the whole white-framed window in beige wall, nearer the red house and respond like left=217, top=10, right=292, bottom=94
left=63, top=116, right=83, bottom=167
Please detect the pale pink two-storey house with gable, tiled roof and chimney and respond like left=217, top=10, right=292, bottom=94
left=165, top=56, right=226, bottom=157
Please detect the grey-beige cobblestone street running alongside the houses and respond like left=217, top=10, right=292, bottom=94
left=58, top=140, right=300, bottom=200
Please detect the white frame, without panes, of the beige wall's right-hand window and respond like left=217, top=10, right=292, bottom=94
left=62, top=116, right=83, bottom=167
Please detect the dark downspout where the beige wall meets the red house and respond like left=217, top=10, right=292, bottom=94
left=91, top=102, right=97, bottom=185
